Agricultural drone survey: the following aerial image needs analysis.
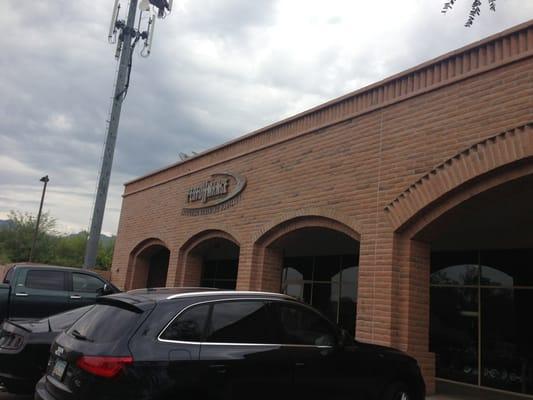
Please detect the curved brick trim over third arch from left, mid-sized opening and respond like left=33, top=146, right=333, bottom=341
left=252, top=207, right=361, bottom=245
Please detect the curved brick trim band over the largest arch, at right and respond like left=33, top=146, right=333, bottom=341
left=385, top=123, right=533, bottom=231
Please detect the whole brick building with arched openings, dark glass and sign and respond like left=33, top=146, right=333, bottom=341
left=113, top=21, right=533, bottom=395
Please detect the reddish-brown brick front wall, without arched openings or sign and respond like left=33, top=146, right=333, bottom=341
left=113, top=21, right=533, bottom=391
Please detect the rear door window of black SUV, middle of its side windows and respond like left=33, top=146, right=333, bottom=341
left=206, top=301, right=276, bottom=344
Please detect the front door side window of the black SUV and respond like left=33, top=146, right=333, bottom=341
left=276, top=303, right=336, bottom=346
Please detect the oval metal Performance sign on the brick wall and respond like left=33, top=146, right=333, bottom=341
left=182, top=172, right=246, bottom=215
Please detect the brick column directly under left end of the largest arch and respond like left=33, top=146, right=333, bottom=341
left=394, top=236, right=435, bottom=394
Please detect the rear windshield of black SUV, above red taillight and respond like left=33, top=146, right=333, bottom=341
left=68, top=304, right=142, bottom=343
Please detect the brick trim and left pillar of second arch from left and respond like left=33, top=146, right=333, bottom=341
left=174, top=226, right=241, bottom=286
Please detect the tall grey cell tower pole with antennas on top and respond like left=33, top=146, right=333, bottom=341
left=83, top=0, right=173, bottom=268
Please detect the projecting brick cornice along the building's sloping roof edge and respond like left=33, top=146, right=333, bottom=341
left=124, top=19, right=533, bottom=186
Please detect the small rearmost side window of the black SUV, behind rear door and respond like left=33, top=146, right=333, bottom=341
left=161, top=304, right=209, bottom=342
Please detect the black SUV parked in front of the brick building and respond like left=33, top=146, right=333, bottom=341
left=35, top=288, right=425, bottom=400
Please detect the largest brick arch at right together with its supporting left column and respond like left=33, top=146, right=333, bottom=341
left=385, top=123, right=533, bottom=393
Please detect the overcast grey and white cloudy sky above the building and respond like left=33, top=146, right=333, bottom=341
left=0, top=0, right=533, bottom=234
